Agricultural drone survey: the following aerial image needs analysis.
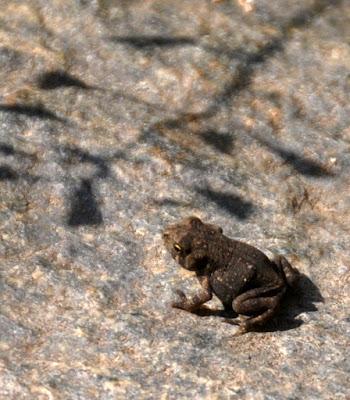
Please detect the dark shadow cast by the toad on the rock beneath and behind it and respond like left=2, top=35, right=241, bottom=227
left=194, top=274, right=324, bottom=332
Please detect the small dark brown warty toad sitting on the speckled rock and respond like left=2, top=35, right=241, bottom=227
left=163, top=217, right=299, bottom=333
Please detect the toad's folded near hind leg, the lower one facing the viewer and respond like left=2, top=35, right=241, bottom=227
left=232, top=286, right=286, bottom=333
